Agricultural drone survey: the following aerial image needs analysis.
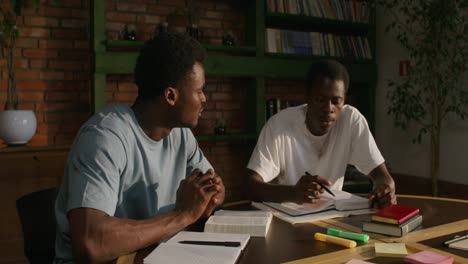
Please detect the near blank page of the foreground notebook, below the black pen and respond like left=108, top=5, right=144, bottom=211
left=143, top=243, right=241, bottom=264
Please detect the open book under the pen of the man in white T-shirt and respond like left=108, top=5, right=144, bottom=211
left=264, top=190, right=369, bottom=216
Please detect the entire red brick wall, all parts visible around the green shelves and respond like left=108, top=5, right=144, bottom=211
left=0, top=0, right=264, bottom=202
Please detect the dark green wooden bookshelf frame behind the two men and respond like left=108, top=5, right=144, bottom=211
left=92, top=0, right=377, bottom=141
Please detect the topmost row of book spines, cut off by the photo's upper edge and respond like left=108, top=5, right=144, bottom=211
left=267, top=0, right=371, bottom=23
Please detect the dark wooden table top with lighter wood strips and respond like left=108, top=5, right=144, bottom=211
left=118, top=195, right=468, bottom=264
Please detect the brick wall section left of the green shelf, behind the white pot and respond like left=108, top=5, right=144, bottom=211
left=0, top=0, right=91, bottom=146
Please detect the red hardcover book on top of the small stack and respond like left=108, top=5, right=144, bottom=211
left=372, top=204, right=419, bottom=224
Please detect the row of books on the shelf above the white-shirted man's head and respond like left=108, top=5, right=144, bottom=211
left=265, top=28, right=372, bottom=60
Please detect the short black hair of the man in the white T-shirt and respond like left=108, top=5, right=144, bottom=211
left=306, top=60, right=349, bottom=95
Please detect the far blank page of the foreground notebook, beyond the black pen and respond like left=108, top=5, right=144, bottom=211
left=167, top=231, right=250, bottom=249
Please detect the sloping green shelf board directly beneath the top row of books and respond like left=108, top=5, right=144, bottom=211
left=265, top=13, right=373, bottom=34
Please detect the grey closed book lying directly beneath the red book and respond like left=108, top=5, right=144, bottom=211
left=362, top=214, right=423, bottom=237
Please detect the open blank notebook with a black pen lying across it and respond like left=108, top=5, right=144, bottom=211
left=143, top=231, right=250, bottom=264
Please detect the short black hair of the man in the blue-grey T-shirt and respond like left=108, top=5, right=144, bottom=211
left=134, top=33, right=206, bottom=100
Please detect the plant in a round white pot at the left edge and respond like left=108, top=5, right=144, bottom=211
left=0, top=0, right=39, bottom=145
